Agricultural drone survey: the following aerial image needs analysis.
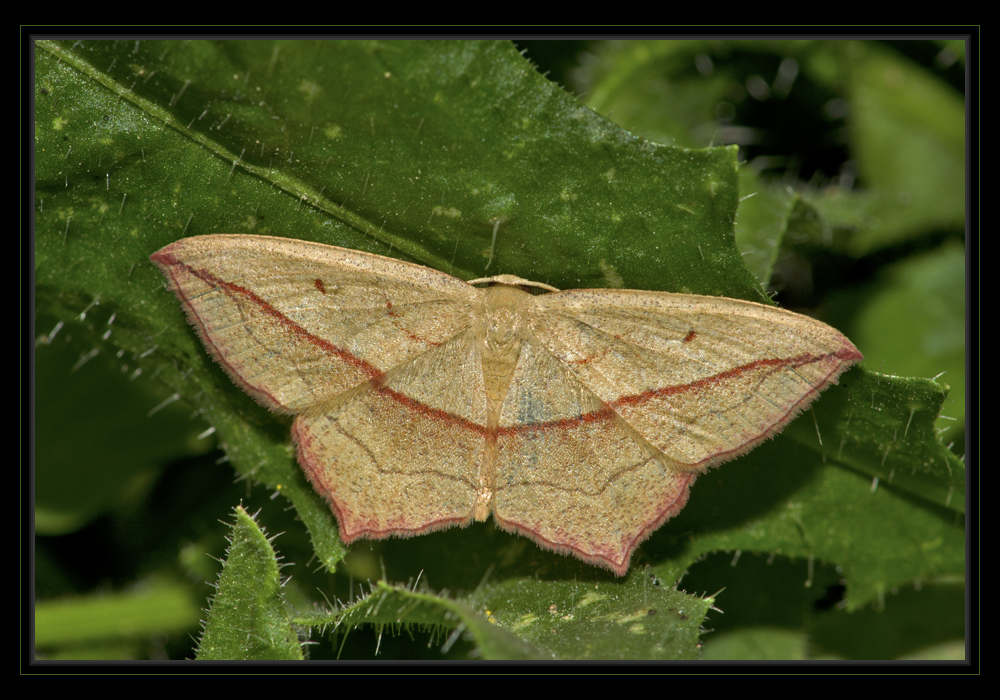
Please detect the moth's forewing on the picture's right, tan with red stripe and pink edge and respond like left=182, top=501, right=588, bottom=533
left=533, top=290, right=861, bottom=470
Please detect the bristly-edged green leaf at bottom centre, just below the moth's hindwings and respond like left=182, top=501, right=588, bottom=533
left=296, top=572, right=713, bottom=660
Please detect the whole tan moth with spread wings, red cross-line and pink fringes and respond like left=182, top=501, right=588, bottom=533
left=151, top=235, right=862, bottom=576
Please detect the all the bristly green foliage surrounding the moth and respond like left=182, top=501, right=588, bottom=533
left=34, top=41, right=965, bottom=659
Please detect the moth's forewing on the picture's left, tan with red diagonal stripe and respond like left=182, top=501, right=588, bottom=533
left=152, top=235, right=477, bottom=412
